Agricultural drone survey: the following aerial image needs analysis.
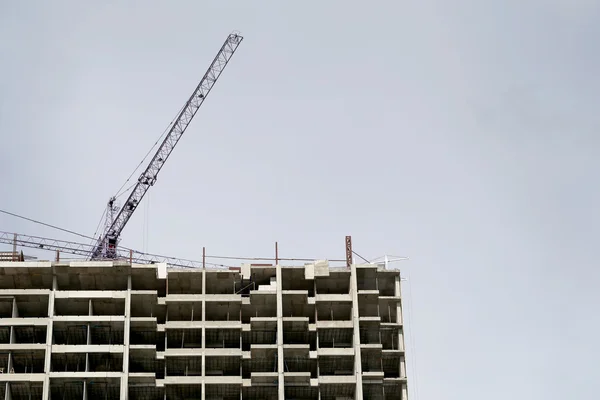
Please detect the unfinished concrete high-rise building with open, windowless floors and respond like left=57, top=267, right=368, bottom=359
left=0, top=261, right=407, bottom=400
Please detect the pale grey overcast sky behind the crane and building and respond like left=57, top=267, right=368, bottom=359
left=0, top=0, right=600, bottom=400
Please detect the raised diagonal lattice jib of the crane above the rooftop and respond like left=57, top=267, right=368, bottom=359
left=91, top=34, right=243, bottom=260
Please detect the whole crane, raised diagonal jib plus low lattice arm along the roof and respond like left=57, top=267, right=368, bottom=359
left=0, top=33, right=243, bottom=266
